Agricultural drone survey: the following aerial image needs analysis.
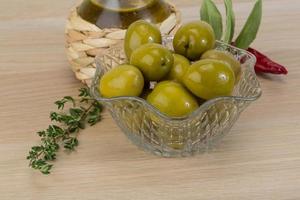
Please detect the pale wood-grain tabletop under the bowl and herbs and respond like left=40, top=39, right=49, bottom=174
left=0, top=0, right=300, bottom=200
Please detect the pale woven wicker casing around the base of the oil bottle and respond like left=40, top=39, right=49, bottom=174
left=65, top=1, right=181, bottom=85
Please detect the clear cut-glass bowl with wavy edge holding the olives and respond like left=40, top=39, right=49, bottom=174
left=91, top=37, right=262, bottom=157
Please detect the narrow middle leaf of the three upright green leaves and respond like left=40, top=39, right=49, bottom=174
left=223, top=0, right=235, bottom=44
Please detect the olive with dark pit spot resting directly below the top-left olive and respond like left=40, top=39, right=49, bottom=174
left=130, top=43, right=174, bottom=81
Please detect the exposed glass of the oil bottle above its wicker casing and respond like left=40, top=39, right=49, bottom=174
left=78, top=0, right=171, bottom=29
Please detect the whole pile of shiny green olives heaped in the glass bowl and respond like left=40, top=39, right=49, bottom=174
left=99, top=20, right=241, bottom=117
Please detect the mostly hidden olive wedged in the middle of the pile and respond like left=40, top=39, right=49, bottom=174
left=167, top=54, right=190, bottom=83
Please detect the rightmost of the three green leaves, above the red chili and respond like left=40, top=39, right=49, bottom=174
left=235, top=0, right=262, bottom=49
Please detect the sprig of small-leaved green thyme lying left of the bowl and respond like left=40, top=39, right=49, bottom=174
left=27, top=88, right=102, bottom=174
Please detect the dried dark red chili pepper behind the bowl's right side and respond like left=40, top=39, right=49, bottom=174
left=248, top=48, right=288, bottom=74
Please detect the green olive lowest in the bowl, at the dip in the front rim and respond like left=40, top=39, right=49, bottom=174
left=147, top=81, right=198, bottom=117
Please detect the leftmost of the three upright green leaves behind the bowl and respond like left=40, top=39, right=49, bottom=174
left=200, top=0, right=223, bottom=40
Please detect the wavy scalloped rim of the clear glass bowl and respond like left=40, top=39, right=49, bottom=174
left=90, top=36, right=262, bottom=121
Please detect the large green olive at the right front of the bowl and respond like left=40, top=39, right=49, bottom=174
left=184, top=59, right=235, bottom=100
